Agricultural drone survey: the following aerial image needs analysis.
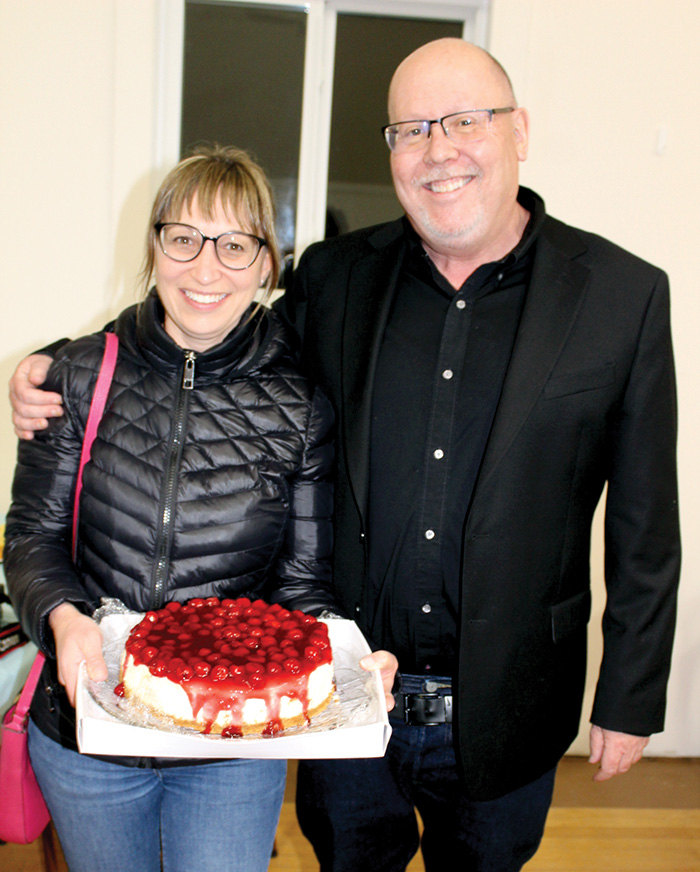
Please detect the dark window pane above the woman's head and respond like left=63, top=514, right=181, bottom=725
left=180, top=0, right=306, bottom=253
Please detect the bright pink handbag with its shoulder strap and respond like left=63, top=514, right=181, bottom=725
left=0, top=333, right=119, bottom=845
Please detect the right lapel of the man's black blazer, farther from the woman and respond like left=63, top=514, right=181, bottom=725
left=474, top=228, right=590, bottom=490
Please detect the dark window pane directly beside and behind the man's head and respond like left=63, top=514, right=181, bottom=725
left=327, top=15, right=463, bottom=235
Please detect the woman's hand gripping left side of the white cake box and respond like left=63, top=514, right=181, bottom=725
left=49, top=603, right=107, bottom=706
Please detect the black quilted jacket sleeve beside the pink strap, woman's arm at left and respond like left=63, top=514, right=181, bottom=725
left=4, top=350, right=91, bottom=655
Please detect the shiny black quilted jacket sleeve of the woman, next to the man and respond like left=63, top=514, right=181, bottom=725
left=271, top=388, right=340, bottom=614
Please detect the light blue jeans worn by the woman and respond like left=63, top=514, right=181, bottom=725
left=29, top=721, right=286, bottom=872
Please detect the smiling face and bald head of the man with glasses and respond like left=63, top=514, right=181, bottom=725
left=389, top=47, right=527, bottom=257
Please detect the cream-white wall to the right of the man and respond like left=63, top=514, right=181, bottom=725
left=489, top=0, right=700, bottom=755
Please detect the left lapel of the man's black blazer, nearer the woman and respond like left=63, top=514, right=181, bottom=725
left=341, top=221, right=405, bottom=516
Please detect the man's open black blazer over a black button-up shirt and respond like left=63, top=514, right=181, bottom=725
left=280, top=192, right=680, bottom=799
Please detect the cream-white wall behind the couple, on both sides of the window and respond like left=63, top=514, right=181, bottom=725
left=0, top=0, right=700, bottom=755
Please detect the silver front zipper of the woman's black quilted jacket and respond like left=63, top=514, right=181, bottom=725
left=151, top=351, right=197, bottom=609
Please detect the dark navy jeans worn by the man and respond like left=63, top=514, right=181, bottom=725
left=297, top=687, right=556, bottom=872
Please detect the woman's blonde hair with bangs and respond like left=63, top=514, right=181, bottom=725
left=141, top=145, right=281, bottom=305
